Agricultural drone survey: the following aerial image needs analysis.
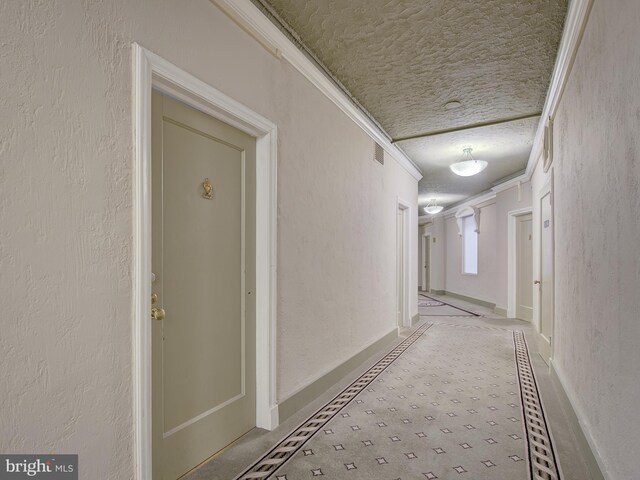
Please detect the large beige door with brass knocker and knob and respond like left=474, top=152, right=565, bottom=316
left=150, top=92, right=256, bottom=480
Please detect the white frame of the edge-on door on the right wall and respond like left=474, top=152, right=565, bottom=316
left=533, top=174, right=556, bottom=364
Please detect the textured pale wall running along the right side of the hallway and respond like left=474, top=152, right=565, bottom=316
left=533, top=0, right=640, bottom=480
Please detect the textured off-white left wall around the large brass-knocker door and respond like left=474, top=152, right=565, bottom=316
left=0, top=0, right=418, bottom=480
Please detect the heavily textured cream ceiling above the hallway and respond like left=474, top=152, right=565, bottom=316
left=254, top=0, right=567, bottom=210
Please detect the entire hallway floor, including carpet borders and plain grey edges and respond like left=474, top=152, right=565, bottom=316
left=185, top=294, right=591, bottom=480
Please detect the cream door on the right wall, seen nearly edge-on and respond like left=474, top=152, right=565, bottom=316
left=539, top=192, right=553, bottom=363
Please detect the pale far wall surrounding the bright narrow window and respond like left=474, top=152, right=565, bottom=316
left=444, top=201, right=497, bottom=303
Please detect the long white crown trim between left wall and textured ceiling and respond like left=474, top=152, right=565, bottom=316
left=211, top=0, right=422, bottom=180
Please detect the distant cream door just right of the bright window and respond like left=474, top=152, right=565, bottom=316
left=516, top=214, right=533, bottom=322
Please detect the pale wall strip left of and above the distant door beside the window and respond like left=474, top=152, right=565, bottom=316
left=495, top=182, right=531, bottom=310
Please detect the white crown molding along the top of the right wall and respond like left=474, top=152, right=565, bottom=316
left=525, top=0, right=593, bottom=179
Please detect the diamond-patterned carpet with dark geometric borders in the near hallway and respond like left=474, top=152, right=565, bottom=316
left=236, top=323, right=561, bottom=480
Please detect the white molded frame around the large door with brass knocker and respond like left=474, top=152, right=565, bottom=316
left=132, top=42, right=279, bottom=480
